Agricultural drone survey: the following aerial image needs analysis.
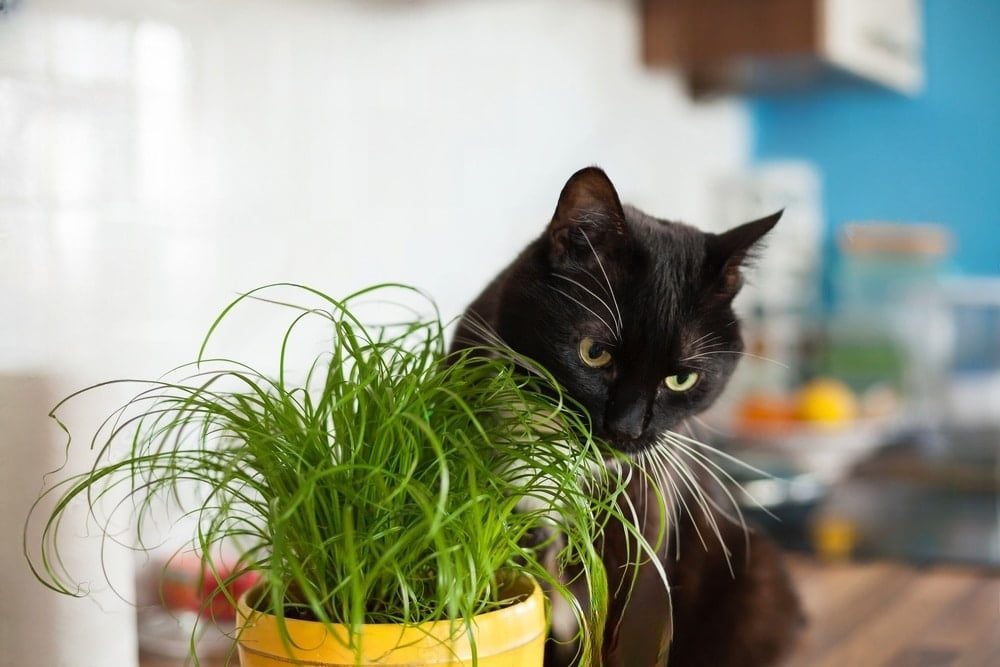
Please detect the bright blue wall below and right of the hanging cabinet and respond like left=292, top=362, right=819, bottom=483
left=751, top=0, right=1000, bottom=274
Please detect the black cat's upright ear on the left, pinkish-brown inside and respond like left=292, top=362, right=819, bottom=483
left=548, top=167, right=626, bottom=263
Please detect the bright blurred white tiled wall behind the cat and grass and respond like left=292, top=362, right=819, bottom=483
left=0, top=0, right=748, bottom=664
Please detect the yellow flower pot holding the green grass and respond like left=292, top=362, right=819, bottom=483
left=238, top=577, right=546, bottom=667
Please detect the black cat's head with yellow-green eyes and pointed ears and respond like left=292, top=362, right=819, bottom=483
left=496, top=167, right=781, bottom=452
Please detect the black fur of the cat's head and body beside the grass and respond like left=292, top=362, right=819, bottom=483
left=453, top=167, right=802, bottom=667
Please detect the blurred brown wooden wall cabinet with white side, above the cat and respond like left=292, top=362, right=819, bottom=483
left=643, top=0, right=923, bottom=94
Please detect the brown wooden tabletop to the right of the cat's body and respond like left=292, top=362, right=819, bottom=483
left=141, top=557, right=1000, bottom=667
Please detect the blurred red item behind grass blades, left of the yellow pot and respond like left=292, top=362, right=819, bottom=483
left=160, top=554, right=260, bottom=621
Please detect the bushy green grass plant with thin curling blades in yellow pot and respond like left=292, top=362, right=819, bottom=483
left=25, top=285, right=653, bottom=664
